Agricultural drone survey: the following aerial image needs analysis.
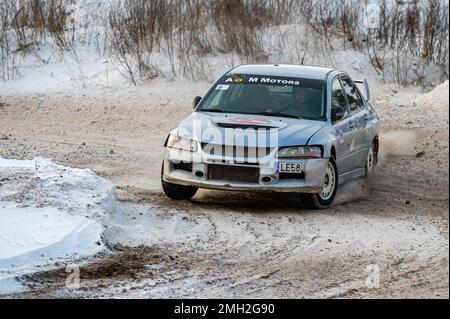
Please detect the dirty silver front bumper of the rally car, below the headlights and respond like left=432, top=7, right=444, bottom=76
left=162, top=148, right=328, bottom=193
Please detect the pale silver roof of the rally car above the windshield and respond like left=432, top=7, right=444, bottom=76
left=228, top=64, right=335, bottom=80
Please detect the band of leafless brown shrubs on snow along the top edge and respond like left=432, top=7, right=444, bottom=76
left=0, top=0, right=449, bottom=85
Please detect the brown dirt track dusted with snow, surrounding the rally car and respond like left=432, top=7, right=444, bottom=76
left=0, top=83, right=449, bottom=298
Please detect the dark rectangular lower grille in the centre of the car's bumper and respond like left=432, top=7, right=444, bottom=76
left=208, top=165, right=259, bottom=183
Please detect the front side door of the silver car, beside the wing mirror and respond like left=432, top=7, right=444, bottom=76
left=331, top=77, right=355, bottom=175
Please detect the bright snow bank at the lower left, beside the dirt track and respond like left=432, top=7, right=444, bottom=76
left=0, top=157, right=116, bottom=294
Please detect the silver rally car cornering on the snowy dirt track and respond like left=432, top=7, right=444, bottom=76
left=161, top=65, right=380, bottom=208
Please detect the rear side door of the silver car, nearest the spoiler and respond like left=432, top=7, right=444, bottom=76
left=341, top=75, right=370, bottom=169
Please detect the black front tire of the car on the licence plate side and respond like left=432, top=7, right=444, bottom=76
left=300, top=157, right=339, bottom=209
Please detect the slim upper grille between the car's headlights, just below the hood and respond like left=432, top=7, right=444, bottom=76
left=202, top=143, right=273, bottom=159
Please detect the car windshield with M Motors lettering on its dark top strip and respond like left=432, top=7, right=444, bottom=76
left=197, top=75, right=326, bottom=120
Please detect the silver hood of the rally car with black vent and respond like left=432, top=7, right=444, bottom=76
left=172, top=112, right=326, bottom=147
